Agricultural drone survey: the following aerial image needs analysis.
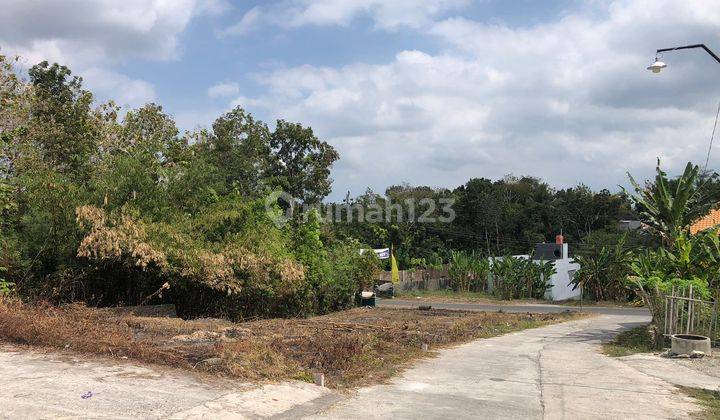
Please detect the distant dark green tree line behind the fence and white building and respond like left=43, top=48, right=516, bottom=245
left=328, top=169, right=720, bottom=269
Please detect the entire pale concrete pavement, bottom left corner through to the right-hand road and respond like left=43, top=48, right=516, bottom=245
left=0, top=306, right=698, bottom=420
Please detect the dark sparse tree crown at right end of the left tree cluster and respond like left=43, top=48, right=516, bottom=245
left=269, top=120, right=340, bottom=204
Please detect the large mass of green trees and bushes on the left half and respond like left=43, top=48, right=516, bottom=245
left=0, top=56, right=350, bottom=318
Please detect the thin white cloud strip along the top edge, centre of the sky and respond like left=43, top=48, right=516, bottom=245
left=223, top=0, right=469, bottom=35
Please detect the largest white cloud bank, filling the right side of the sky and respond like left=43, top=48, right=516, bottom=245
left=229, top=0, right=720, bottom=198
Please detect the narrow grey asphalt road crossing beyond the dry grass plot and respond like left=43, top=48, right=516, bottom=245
left=377, top=299, right=650, bottom=316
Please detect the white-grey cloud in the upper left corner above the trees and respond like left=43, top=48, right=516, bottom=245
left=0, top=0, right=219, bottom=110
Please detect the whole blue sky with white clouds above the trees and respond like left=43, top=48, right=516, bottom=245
left=0, top=0, right=720, bottom=200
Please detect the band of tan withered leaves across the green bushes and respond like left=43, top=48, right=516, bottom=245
left=75, top=205, right=305, bottom=296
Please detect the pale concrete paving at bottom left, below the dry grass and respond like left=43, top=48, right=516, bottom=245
left=0, top=345, right=339, bottom=419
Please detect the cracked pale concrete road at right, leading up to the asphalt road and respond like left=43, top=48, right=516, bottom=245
left=313, top=314, right=699, bottom=420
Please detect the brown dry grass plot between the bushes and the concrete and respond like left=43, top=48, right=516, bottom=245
left=0, top=300, right=579, bottom=388
